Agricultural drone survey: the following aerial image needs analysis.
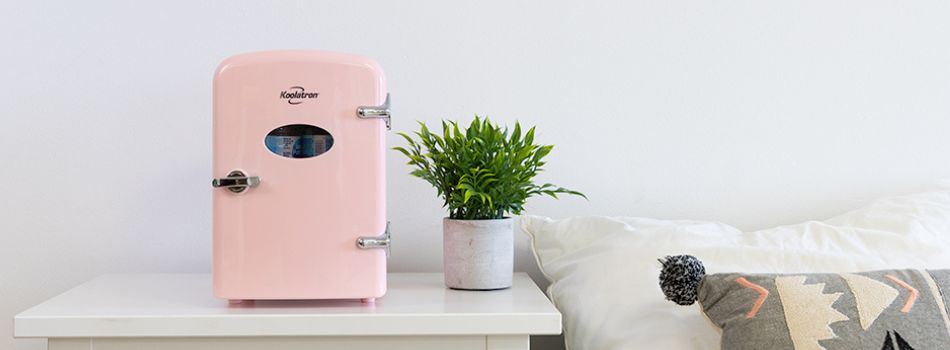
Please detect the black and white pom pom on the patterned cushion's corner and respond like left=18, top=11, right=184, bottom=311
left=660, top=255, right=706, bottom=305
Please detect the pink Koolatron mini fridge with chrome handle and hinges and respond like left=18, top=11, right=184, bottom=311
left=212, top=51, right=390, bottom=302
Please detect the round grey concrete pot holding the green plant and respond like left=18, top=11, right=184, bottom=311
left=442, top=218, right=515, bottom=290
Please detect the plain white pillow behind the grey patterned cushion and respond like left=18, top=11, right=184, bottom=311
left=521, top=188, right=950, bottom=350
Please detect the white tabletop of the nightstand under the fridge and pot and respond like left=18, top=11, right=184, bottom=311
left=14, top=273, right=561, bottom=338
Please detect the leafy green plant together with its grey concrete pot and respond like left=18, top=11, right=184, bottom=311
left=394, top=116, right=586, bottom=290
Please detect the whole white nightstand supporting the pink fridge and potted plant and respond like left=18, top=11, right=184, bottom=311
left=14, top=273, right=561, bottom=350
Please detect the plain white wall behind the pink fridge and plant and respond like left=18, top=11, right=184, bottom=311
left=0, top=0, right=950, bottom=349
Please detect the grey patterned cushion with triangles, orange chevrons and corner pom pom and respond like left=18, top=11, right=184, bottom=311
left=660, top=255, right=950, bottom=350
